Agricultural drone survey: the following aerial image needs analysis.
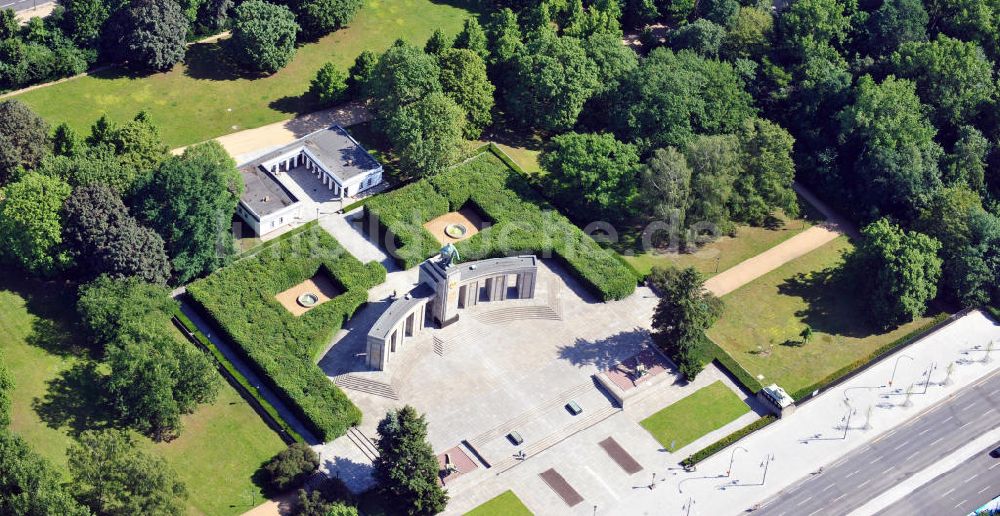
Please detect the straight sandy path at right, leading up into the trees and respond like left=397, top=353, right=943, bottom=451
left=705, top=183, right=858, bottom=297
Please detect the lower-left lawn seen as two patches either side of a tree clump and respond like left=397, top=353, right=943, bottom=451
left=0, top=271, right=284, bottom=514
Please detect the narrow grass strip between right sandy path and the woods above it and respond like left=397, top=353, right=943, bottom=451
left=623, top=197, right=822, bottom=278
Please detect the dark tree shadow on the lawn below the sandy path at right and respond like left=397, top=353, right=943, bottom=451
left=778, top=266, right=876, bottom=338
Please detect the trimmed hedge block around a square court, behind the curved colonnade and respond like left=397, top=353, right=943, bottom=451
left=365, top=148, right=638, bottom=300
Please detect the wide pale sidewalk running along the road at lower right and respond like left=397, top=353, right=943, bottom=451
left=597, top=311, right=1000, bottom=514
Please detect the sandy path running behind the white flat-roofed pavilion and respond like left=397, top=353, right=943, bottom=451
left=171, top=102, right=372, bottom=163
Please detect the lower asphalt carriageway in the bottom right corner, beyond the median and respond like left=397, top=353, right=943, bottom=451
left=879, top=443, right=1000, bottom=516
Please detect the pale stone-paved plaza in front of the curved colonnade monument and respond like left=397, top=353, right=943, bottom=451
left=308, top=217, right=759, bottom=500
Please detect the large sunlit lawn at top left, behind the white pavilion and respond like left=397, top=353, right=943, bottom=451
left=6, top=0, right=475, bottom=147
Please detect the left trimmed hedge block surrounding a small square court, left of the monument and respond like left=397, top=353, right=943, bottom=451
left=188, top=224, right=386, bottom=441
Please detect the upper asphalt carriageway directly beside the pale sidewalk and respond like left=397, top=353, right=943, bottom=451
left=759, top=373, right=1000, bottom=516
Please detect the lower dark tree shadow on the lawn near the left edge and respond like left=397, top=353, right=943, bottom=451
left=31, top=360, right=114, bottom=436
